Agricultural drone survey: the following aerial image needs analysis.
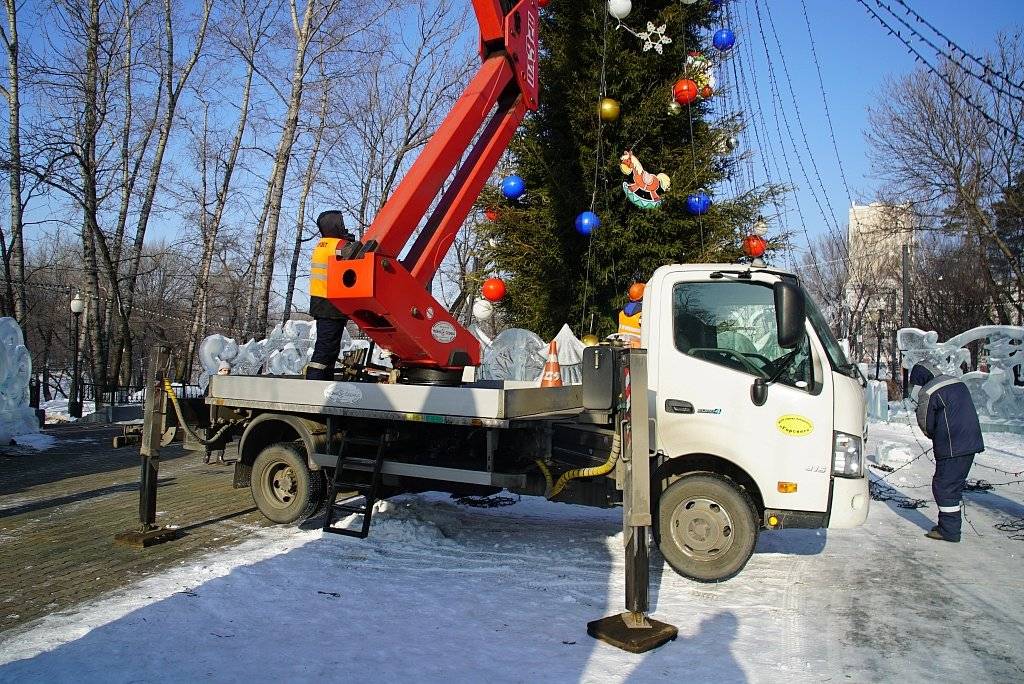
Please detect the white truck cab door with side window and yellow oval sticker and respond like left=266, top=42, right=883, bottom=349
left=656, top=272, right=833, bottom=511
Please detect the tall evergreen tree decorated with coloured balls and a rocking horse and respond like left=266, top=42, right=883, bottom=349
left=481, top=0, right=778, bottom=338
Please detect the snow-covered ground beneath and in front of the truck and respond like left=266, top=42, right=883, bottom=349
left=0, top=419, right=1024, bottom=682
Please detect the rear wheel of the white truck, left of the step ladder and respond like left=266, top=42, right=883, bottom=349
left=249, top=441, right=325, bottom=524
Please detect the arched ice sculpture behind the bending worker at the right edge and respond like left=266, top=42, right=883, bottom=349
left=896, top=326, right=1024, bottom=424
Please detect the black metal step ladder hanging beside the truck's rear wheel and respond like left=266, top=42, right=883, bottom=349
left=324, top=432, right=387, bottom=540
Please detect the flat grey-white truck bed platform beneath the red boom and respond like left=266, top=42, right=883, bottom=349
left=206, top=376, right=583, bottom=428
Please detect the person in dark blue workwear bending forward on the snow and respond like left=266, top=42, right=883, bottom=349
left=909, top=364, right=985, bottom=542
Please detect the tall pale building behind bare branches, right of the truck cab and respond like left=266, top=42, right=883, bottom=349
left=846, top=202, right=918, bottom=373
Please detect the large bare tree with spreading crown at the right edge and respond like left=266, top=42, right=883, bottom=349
left=866, top=36, right=1024, bottom=323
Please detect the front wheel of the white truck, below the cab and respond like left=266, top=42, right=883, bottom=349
left=655, top=473, right=759, bottom=582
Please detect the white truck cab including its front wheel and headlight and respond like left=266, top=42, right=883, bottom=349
left=641, top=264, right=869, bottom=581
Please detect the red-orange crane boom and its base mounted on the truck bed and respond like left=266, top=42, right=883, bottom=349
left=327, top=0, right=539, bottom=371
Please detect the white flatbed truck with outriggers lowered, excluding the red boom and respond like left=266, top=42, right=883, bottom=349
left=121, top=264, right=869, bottom=649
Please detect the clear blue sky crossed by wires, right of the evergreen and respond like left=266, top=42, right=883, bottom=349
left=722, top=0, right=1024, bottom=247
